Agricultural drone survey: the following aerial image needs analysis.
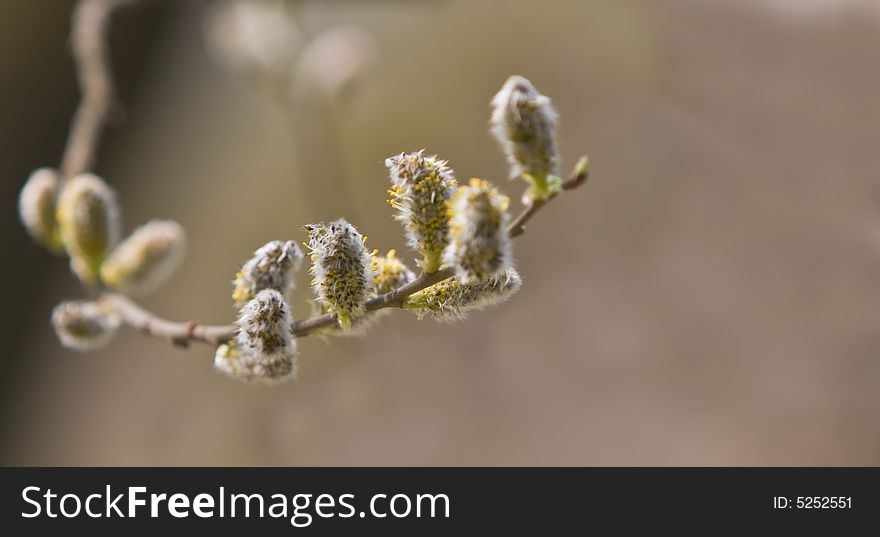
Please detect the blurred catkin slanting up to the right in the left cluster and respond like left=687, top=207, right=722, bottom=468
left=101, top=220, right=186, bottom=295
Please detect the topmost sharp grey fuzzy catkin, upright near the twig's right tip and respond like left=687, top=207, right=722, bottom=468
left=491, top=75, right=562, bottom=199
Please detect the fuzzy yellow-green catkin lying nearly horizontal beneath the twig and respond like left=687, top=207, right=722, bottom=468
left=403, top=268, right=522, bottom=322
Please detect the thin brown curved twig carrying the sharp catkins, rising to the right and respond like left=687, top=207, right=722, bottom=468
left=101, top=163, right=588, bottom=347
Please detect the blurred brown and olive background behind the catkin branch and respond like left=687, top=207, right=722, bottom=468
left=0, top=0, right=880, bottom=465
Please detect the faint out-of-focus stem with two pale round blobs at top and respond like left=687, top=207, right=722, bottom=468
left=204, top=0, right=376, bottom=220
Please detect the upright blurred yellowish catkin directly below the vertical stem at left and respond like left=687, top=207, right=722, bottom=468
left=57, top=173, right=120, bottom=283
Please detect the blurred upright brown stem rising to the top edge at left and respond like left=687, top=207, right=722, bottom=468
left=60, top=0, right=132, bottom=179
